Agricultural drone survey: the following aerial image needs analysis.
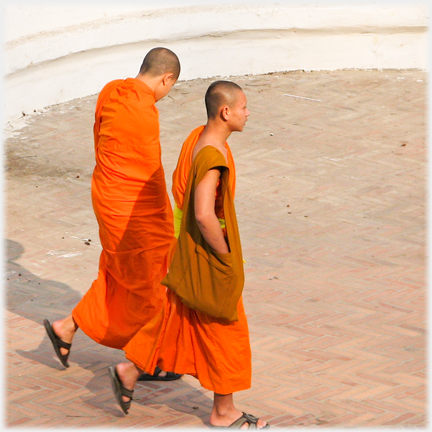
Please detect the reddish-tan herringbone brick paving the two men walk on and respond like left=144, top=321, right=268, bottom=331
left=5, top=71, right=427, bottom=428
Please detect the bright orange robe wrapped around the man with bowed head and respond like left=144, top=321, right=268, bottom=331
left=72, top=78, right=173, bottom=349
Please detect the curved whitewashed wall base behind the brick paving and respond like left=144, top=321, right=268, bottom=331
left=4, top=3, right=427, bottom=120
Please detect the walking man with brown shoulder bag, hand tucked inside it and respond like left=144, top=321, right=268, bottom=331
left=110, top=81, right=269, bottom=429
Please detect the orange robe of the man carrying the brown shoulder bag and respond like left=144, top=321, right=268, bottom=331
left=124, top=127, right=252, bottom=394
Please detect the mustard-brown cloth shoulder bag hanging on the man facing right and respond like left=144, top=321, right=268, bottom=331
left=162, top=146, right=244, bottom=321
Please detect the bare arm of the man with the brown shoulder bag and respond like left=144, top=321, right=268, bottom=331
left=194, top=169, right=229, bottom=253
